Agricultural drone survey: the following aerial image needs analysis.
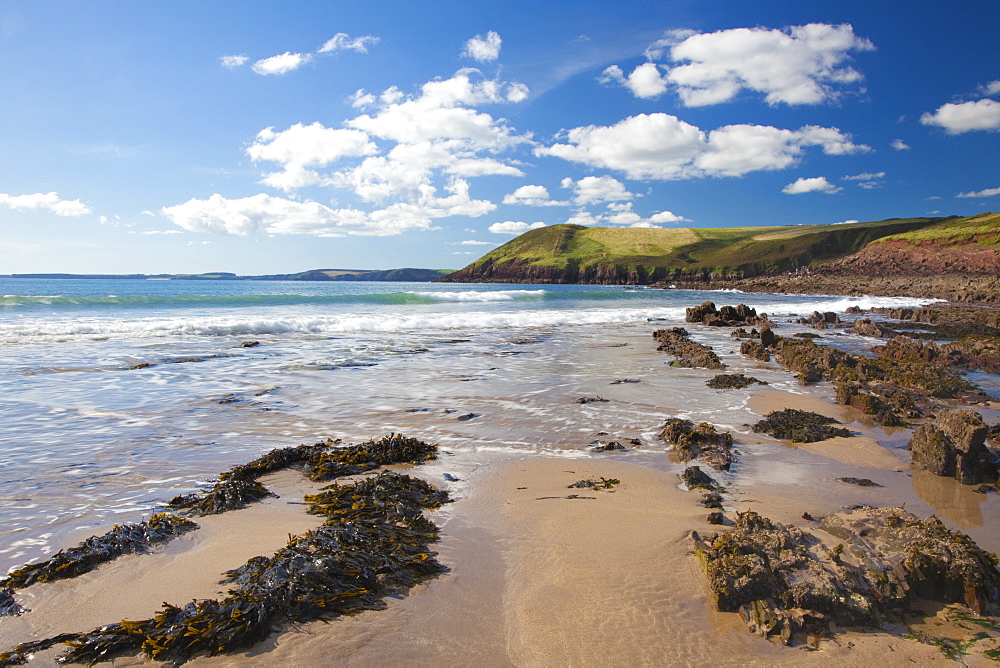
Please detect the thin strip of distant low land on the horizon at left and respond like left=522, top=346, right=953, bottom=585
left=2, top=268, right=453, bottom=283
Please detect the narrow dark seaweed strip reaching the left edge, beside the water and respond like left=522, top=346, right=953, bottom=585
left=0, top=513, right=198, bottom=589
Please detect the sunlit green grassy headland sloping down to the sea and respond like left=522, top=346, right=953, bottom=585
left=445, top=218, right=952, bottom=283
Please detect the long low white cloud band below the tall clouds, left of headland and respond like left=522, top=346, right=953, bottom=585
left=160, top=180, right=496, bottom=237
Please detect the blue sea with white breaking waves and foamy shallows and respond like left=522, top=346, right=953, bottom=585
left=0, top=279, right=982, bottom=572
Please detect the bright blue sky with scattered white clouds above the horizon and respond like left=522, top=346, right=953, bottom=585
left=0, top=0, right=1000, bottom=274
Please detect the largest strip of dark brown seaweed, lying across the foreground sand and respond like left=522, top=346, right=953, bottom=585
left=50, top=472, right=448, bottom=663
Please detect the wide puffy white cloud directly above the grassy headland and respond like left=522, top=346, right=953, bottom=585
left=535, top=113, right=871, bottom=180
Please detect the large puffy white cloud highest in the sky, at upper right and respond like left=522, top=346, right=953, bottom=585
left=632, top=23, right=875, bottom=107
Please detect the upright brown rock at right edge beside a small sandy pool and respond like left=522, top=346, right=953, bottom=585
left=908, top=409, right=997, bottom=485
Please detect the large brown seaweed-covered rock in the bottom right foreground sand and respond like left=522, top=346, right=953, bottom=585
left=692, top=507, right=1000, bottom=644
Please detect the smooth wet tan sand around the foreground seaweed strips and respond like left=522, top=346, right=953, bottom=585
left=0, top=458, right=944, bottom=667
